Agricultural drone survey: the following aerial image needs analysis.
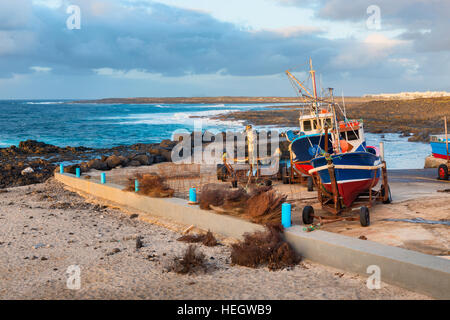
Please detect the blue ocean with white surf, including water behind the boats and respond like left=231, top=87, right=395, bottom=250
left=0, top=100, right=431, bottom=169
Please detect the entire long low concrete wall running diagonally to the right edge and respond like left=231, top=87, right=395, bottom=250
left=55, top=173, right=450, bottom=299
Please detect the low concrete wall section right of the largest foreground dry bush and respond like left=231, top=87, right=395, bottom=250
left=285, top=226, right=450, bottom=299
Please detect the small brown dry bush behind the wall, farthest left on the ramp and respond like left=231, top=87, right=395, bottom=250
left=125, top=173, right=174, bottom=198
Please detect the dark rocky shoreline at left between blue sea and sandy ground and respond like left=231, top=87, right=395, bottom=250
left=0, top=140, right=176, bottom=189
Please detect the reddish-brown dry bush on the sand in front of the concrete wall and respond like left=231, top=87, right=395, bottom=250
left=231, top=224, right=301, bottom=271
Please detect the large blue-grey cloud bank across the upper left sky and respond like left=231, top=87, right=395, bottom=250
left=0, top=0, right=338, bottom=80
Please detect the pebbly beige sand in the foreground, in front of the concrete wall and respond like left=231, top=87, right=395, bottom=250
left=0, top=179, right=428, bottom=299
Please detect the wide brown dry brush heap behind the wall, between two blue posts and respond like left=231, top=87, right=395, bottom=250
left=199, top=184, right=287, bottom=224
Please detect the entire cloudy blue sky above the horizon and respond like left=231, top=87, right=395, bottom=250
left=0, top=0, right=450, bottom=99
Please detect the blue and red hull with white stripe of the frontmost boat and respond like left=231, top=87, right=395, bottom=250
left=311, top=152, right=381, bottom=207
